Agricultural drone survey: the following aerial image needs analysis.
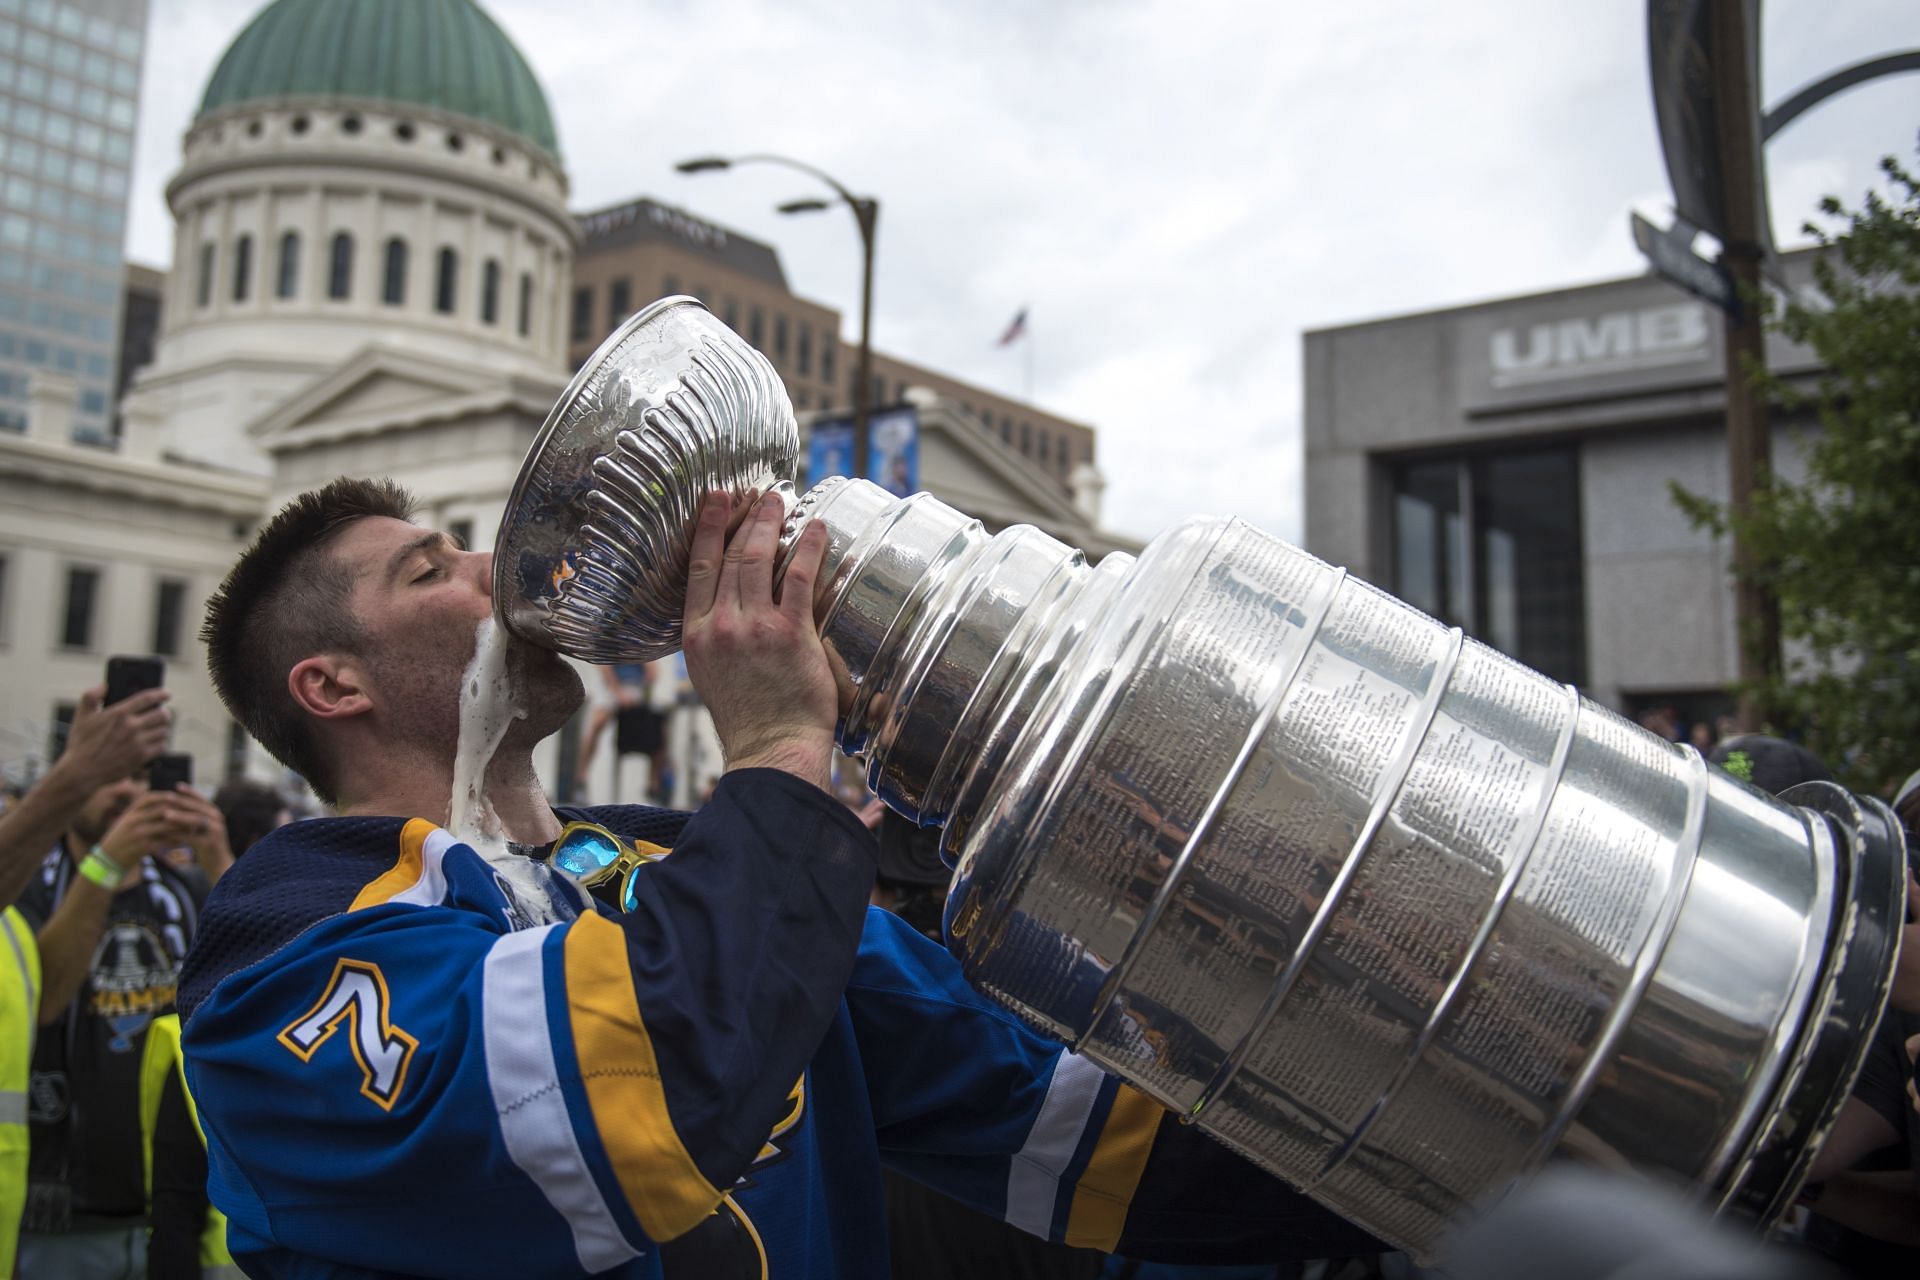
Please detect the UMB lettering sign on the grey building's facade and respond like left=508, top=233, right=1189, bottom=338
left=1488, top=301, right=1713, bottom=388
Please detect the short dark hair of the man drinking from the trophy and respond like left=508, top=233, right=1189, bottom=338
left=200, top=476, right=413, bottom=804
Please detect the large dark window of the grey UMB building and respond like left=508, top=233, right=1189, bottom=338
left=1392, top=447, right=1586, bottom=683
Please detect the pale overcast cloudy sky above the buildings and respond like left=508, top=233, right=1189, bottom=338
left=129, top=0, right=1920, bottom=537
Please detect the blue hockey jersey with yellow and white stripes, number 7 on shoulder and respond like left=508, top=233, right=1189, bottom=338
left=180, top=770, right=1371, bottom=1280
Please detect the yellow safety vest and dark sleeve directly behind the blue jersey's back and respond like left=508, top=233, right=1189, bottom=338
left=140, top=1013, right=240, bottom=1280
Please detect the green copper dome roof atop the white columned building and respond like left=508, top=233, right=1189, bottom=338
left=200, top=0, right=561, bottom=157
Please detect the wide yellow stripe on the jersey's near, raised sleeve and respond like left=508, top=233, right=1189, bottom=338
left=564, top=915, right=720, bottom=1242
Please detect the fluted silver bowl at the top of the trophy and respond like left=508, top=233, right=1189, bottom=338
left=493, top=297, right=801, bottom=662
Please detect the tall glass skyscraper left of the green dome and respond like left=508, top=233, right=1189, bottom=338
left=0, top=0, right=148, bottom=443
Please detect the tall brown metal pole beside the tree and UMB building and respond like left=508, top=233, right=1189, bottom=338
left=1713, top=0, right=1780, bottom=729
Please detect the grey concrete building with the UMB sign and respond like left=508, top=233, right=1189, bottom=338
left=1304, top=255, right=1816, bottom=723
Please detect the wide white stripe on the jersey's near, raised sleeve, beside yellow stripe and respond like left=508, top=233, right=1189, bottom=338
left=478, top=921, right=639, bottom=1272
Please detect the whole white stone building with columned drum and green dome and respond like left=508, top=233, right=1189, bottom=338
left=0, top=0, right=580, bottom=783
